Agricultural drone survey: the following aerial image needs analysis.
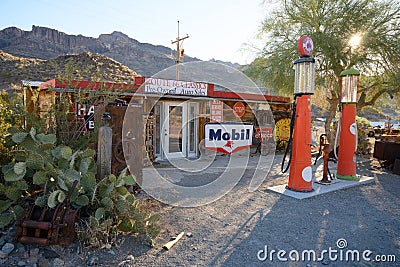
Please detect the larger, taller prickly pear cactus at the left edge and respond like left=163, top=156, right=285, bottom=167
left=0, top=128, right=96, bottom=227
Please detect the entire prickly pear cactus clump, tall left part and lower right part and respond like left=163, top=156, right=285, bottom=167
left=0, top=128, right=159, bottom=245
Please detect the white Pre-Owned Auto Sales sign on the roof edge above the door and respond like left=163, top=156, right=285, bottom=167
left=144, top=78, right=208, bottom=96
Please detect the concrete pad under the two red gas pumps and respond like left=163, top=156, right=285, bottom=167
left=267, top=176, right=374, bottom=199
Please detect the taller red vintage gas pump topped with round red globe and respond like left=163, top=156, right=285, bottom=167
left=281, top=36, right=315, bottom=192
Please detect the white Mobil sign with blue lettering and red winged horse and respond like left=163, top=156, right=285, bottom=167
left=204, top=122, right=253, bottom=154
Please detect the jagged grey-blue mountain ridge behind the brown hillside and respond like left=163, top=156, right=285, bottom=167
left=0, top=26, right=240, bottom=76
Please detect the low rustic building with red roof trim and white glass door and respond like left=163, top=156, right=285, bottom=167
left=24, top=77, right=291, bottom=176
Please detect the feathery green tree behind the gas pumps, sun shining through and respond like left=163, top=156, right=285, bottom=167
left=245, top=0, right=400, bottom=147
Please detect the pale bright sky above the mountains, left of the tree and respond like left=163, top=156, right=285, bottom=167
left=0, top=0, right=273, bottom=64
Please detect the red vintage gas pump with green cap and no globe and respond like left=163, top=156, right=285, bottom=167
left=336, top=69, right=360, bottom=180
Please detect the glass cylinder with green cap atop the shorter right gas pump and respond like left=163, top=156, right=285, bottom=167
left=340, top=69, right=360, bottom=103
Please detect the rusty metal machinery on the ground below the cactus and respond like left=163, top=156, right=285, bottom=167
left=14, top=181, right=80, bottom=246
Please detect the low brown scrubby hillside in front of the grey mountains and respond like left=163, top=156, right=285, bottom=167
left=0, top=50, right=138, bottom=89
